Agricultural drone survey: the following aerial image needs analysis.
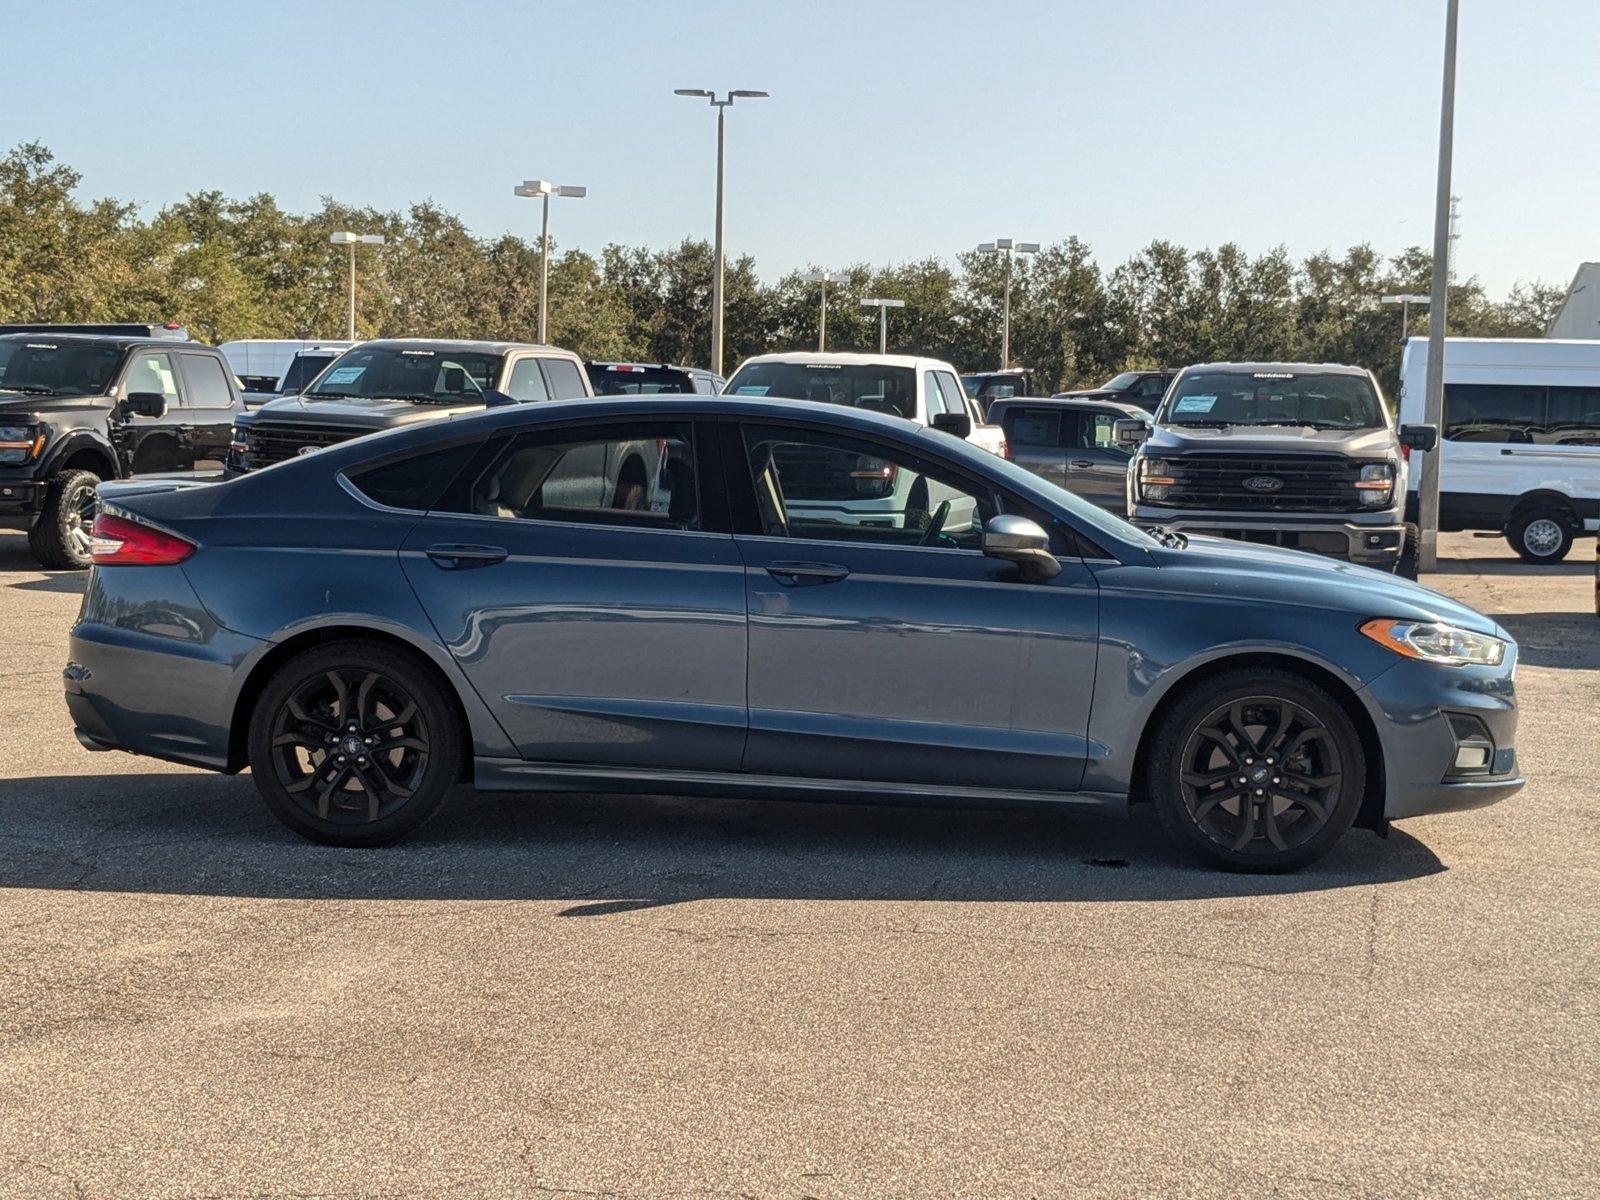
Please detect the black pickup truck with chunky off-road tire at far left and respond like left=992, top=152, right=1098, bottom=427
left=0, top=325, right=245, bottom=568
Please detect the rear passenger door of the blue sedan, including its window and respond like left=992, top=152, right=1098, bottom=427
left=400, top=419, right=746, bottom=770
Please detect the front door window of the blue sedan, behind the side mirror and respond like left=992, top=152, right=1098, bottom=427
left=744, top=426, right=995, bottom=550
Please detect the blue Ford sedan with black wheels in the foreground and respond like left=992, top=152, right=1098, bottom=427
left=66, top=395, right=1522, bottom=870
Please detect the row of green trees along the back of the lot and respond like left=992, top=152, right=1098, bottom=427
left=0, top=142, right=1562, bottom=394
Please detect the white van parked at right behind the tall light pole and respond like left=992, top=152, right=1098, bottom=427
left=1400, top=338, right=1600, bottom=563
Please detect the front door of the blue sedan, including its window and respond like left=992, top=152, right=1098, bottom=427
left=723, top=421, right=1099, bottom=790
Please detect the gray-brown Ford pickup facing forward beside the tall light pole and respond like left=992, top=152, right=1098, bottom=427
left=1117, top=363, right=1437, bottom=578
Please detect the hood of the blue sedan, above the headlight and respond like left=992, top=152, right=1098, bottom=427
left=1152, top=534, right=1512, bottom=642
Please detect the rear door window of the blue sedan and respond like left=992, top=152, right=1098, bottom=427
left=469, top=428, right=699, bottom=530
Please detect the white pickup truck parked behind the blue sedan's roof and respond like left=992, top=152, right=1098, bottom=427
left=722, top=352, right=1006, bottom=530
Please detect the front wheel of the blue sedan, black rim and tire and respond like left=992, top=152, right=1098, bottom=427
left=1146, top=669, right=1366, bottom=874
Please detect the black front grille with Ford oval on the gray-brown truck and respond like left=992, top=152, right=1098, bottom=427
left=1155, top=454, right=1379, bottom=512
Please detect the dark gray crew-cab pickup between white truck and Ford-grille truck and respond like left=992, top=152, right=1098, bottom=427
left=989, top=397, right=1150, bottom=517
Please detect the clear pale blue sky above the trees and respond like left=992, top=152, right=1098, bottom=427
left=0, top=0, right=1600, bottom=291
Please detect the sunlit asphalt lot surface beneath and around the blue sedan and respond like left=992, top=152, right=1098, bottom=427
left=0, top=534, right=1600, bottom=1198
